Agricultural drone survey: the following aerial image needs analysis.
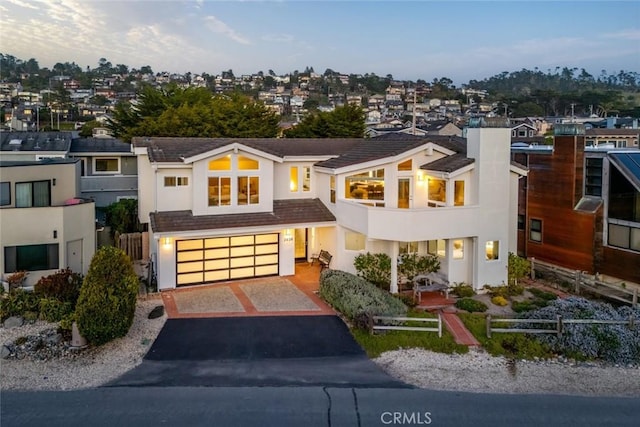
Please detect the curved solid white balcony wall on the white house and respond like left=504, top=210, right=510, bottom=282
left=335, top=200, right=480, bottom=242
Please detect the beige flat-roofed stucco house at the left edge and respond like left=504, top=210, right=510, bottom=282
left=0, top=159, right=96, bottom=286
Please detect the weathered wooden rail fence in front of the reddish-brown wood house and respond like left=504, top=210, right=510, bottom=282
left=529, top=258, right=638, bottom=307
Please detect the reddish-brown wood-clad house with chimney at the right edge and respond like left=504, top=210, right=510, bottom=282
left=512, top=124, right=640, bottom=283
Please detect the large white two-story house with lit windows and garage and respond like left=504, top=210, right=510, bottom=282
left=132, top=119, right=527, bottom=292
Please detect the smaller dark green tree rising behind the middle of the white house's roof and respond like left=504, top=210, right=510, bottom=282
left=285, top=104, right=365, bottom=138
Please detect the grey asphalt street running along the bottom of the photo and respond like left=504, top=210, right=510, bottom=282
left=0, top=387, right=640, bottom=427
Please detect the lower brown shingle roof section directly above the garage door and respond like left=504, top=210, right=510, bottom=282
left=150, top=199, right=336, bottom=233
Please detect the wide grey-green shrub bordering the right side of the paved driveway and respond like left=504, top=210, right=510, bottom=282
left=319, top=270, right=407, bottom=327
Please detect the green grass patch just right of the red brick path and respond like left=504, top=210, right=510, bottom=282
left=458, top=313, right=553, bottom=359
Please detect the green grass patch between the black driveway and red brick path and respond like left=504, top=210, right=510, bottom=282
left=351, top=311, right=469, bottom=358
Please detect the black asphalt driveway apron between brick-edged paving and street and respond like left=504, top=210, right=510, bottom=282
left=107, top=315, right=410, bottom=388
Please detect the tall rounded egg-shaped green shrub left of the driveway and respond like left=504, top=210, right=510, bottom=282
left=76, top=246, right=138, bottom=345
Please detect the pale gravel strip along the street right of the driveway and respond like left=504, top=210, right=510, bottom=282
left=374, top=349, right=640, bottom=397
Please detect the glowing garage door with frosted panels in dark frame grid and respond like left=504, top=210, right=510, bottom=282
left=176, top=233, right=279, bottom=286
